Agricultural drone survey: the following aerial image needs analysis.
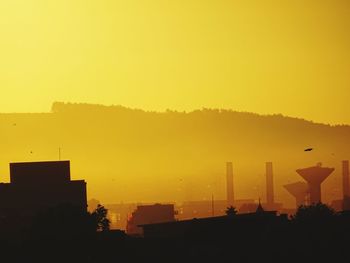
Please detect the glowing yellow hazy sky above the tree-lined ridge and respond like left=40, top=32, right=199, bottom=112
left=0, top=0, right=350, bottom=124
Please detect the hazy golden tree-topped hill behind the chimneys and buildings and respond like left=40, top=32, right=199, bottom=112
left=0, top=102, right=350, bottom=206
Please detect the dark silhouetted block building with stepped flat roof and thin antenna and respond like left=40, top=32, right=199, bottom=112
left=0, top=161, right=87, bottom=216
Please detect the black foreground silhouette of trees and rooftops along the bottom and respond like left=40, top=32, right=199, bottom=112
left=0, top=204, right=350, bottom=262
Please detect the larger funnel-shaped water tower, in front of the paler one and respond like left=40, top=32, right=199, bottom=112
left=297, top=163, right=334, bottom=204
